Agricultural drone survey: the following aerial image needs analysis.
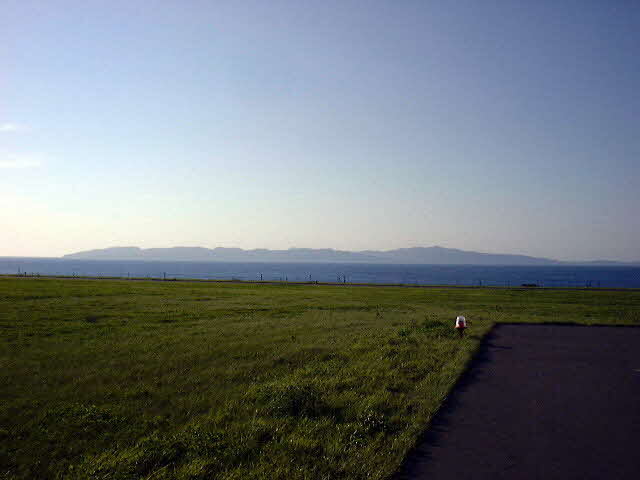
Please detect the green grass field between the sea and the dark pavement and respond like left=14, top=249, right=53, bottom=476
left=0, top=277, right=640, bottom=480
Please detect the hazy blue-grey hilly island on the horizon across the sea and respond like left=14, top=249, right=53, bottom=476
left=63, top=246, right=629, bottom=266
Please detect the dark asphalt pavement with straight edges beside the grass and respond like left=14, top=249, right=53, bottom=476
left=398, top=325, right=640, bottom=480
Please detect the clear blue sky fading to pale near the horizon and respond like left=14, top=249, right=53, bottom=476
left=0, top=0, right=640, bottom=261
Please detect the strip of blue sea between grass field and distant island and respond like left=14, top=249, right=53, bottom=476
left=0, top=257, right=640, bottom=288
